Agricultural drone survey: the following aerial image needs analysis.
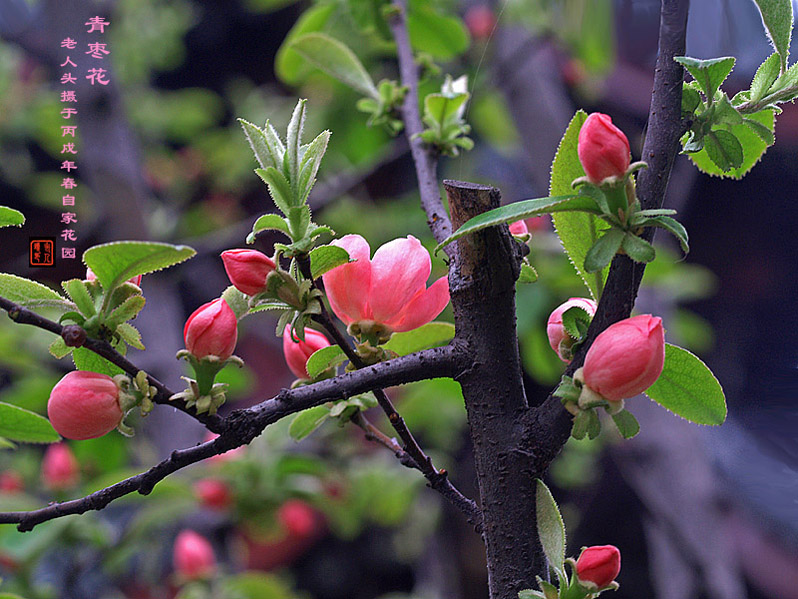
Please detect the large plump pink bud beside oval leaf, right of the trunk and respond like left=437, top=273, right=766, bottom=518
left=583, top=314, right=665, bottom=401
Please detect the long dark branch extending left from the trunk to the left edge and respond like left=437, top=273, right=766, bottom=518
left=0, top=344, right=465, bottom=531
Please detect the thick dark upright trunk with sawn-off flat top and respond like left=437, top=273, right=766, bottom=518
left=444, top=181, right=543, bottom=599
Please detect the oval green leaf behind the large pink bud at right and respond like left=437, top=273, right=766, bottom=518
left=645, top=343, right=726, bottom=425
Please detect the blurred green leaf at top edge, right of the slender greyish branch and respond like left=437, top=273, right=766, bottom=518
left=407, top=2, right=469, bottom=61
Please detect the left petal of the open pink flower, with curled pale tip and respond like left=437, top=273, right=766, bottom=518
left=321, top=235, right=371, bottom=325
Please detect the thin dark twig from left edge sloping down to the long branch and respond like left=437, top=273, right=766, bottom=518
left=0, top=297, right=221, bottom=433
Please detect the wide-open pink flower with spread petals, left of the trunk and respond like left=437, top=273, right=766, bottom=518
left=322, top=235, right=449, bottom=332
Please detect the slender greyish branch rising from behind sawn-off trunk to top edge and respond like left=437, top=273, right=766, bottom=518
left=389, top=0, right=453, bottom=255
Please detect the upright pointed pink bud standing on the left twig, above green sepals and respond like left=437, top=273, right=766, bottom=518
left=183, top=298, right=238, bottom=360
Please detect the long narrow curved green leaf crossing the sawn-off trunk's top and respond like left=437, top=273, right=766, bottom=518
left=435, top=194, right=599, bottom=252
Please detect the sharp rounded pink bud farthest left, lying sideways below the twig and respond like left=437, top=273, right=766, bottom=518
left=47, top=370, right=123, bottom=440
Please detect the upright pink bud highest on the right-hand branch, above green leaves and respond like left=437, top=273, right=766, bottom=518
left=577, top=112, right=631, bottom=185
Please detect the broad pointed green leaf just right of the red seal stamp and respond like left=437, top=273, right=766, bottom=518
left=83, top=241, right=197, bottom=292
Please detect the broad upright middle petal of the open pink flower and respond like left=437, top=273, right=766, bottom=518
left=369, top=235, right=432, bottom=323
